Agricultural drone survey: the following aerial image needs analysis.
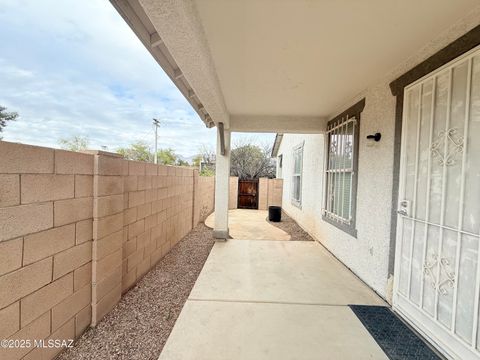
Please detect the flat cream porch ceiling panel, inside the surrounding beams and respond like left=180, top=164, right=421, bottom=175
left=195, top=0, right=479, bottom=116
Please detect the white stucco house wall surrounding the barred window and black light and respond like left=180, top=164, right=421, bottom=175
left=278, top=7, right=480, bottom=301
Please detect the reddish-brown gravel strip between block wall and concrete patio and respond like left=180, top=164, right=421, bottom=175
left=58, top=224, right=214, bottom=360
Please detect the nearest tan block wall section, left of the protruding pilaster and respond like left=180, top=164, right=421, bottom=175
left=0, top=141, right=93, bottom=360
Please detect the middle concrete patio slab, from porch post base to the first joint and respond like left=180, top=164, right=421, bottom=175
left=190, top=240, right=385, bottom=305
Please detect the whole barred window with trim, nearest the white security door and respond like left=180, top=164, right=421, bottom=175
left=323, top=100, right=365, bottom=236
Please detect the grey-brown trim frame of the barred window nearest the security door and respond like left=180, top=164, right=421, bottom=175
left=322, top=98, right=365, bottom=238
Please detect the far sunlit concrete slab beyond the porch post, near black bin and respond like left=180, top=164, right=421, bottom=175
left=205, top=209, right=290, bottom=240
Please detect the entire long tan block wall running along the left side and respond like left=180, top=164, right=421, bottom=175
left=0, top=141, right=214, bottom=360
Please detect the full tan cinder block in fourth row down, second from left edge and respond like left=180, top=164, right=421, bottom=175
left=23, top=224, right=75, bottom=265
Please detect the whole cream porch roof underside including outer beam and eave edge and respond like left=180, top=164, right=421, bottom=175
left=111, top=0, right=478, bottom=133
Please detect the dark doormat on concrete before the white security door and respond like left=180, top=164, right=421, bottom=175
left=350, top=305, right=440, bottom=360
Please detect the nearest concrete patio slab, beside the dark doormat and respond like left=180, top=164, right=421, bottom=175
left=160, top=300, right=388, bottom=360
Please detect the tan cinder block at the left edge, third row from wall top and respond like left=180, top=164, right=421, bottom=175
left=0, top=203, right=53, bottom=241
